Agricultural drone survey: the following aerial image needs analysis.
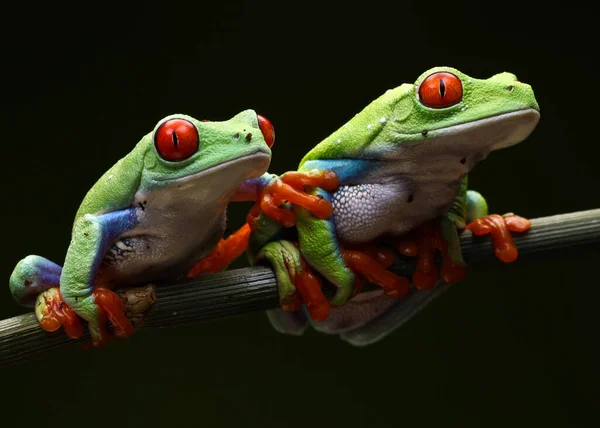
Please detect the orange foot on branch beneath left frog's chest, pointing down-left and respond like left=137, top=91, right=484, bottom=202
left=187, top=223, right=251, bottom=278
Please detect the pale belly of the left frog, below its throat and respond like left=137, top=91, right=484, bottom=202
left=98, top=188, right=226, bottom=286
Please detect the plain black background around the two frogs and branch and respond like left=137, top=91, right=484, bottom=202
left=0, top=1, right=600, bottom=427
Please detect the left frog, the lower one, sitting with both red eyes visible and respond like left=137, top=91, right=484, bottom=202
left=10, top=110, right=275, bottom=345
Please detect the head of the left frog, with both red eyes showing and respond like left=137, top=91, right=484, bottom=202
left=141, top=110, right=275, bottom=190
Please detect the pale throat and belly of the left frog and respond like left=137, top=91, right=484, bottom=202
left=96, top=156, right=268, bottom=287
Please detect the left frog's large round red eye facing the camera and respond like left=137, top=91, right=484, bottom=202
left=154, top=119, right=200, bottom=162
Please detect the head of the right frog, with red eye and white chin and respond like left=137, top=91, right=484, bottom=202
left=406, top=67, right=540, bottom=150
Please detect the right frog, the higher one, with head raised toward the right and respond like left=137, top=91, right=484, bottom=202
left=247, top=67, right=540, bottom=345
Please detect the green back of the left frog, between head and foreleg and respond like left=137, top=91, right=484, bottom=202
left=74, top=140, right=147, bottom=223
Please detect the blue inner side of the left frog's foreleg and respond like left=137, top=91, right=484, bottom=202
left=90, top=208, right=138, bottom=290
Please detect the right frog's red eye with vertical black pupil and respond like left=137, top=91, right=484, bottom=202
left=419, top=72, right=462, bottom=108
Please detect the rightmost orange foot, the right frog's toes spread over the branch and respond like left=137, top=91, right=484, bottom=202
left=465, top=213, right=531, bottom=263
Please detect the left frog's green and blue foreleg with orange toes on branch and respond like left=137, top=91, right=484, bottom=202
left=41, top=209, right=136, bottom=345
